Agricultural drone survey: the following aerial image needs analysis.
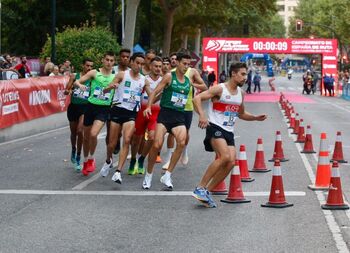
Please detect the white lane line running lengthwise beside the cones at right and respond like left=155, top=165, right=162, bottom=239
left=281, top=107, right=350, bottom=252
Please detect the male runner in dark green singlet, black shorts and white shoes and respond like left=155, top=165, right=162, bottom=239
left=143, top=53, right=191, bottom=190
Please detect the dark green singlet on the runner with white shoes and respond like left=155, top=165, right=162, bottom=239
left=160, top=72, right=191, bottom=112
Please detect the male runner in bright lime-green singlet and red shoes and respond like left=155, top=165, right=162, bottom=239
left=74, top=52, right=115, bottom=176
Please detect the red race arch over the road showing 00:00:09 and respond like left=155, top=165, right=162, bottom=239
left=203, top=38, right=338, bottom=91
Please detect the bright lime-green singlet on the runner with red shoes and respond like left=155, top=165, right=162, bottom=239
left=88, top=70, right=115, bottom=105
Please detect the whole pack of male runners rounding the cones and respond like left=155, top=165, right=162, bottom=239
left=66, top=49, right=266, bottom=207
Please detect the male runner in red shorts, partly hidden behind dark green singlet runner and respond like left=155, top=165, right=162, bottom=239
left=128, top=56, right=162, bottom=175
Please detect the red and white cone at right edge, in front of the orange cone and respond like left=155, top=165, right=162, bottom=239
left=321, top=161, right=349, bottom=210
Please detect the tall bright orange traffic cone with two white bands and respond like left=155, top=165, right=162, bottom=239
left=308, top=133, right=331, bottom=190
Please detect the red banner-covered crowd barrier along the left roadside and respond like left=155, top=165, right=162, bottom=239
left=0, top=76, right=70, bottom=129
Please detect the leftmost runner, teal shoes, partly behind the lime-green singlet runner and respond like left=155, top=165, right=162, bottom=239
left=65, top=58, right=94, bottom=172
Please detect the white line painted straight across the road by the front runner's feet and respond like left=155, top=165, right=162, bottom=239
left=0, top=189, right=306, bottom=197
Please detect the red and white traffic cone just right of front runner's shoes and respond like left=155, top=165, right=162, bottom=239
left=220, top=160, right=250, bottom=204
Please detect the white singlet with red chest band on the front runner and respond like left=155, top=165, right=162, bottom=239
left=208, top=83, right=243, bottom=132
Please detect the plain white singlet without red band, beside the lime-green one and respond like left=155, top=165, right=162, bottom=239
left=113, top=70, right=146, bottom=112
